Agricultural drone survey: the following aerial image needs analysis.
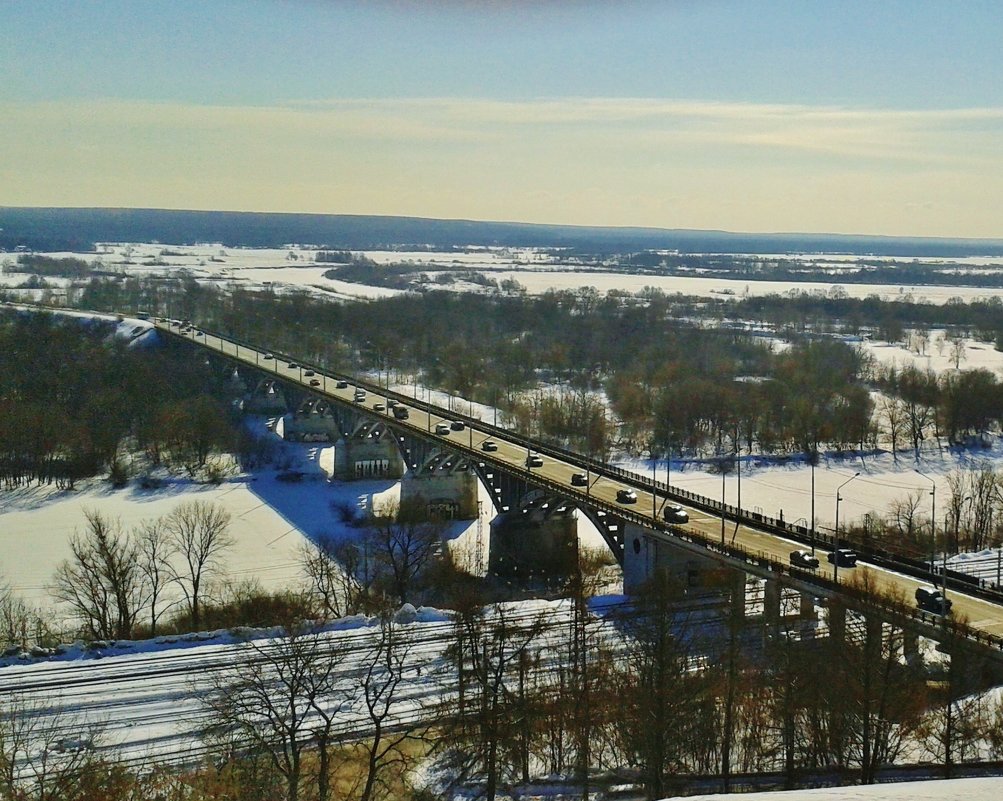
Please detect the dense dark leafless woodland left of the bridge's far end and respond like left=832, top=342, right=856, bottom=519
left=0, top=312, right=236, bottom=489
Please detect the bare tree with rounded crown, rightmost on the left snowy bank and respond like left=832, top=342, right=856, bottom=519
left=166, top=500, right=234, bottom=629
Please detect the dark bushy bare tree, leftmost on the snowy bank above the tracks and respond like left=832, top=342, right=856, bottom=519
left=52, top=510, right=144, bottom=639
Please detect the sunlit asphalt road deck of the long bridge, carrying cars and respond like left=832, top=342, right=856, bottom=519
left=153, top=319, right=1003, bottom=655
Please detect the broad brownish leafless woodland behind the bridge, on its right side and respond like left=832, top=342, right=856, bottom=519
left=58, top=276, right=1003, bottom=463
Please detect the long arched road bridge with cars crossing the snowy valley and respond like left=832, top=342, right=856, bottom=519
left=151, top=318, right=1003, bottom=665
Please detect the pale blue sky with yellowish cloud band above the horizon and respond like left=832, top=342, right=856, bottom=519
left=0, top=0, right=1003, bottom=238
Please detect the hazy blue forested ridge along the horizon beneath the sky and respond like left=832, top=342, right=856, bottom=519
left=0, top=208, right=1003, bottom=258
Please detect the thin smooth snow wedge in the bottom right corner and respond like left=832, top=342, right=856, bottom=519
left=687, top=777, right=1003, bottom=801
